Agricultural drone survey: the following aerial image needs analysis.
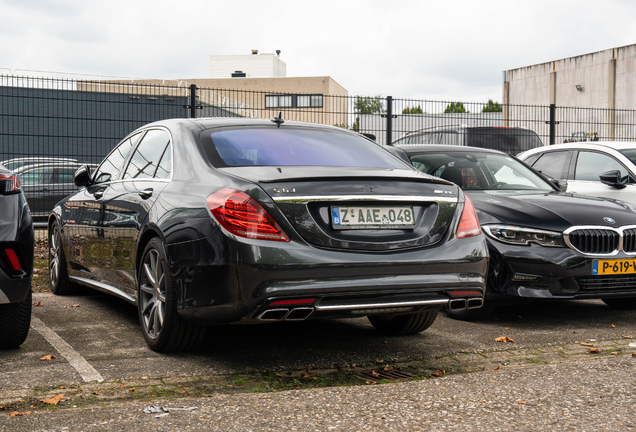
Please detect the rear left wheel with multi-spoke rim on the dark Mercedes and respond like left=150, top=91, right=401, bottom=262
left=137, top=237, right=205, bottom=352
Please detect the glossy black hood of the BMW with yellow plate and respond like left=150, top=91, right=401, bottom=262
left=466, top=191, right=636, bottom=231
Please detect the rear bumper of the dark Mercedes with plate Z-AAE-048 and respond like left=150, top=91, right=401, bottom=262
left=167, top=236, right=488, bottom=324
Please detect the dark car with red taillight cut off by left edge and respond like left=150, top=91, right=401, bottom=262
left=0, top=165, right=34, bottom=348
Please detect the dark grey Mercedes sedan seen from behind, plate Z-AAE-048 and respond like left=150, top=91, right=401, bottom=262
left=49, top=117, right=488, bottom=351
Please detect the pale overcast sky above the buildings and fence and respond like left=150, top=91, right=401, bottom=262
left=0, top=0, right=636, bottom=102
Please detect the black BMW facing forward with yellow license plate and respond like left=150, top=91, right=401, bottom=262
left=391, top=146, right=636, bottom=319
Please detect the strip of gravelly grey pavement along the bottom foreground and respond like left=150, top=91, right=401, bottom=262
left=0, top=356, right=636, bottom=432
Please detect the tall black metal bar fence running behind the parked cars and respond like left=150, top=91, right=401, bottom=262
left=0, top=75, right=636, bottom=219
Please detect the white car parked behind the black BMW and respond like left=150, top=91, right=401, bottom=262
left=517, top=141, right=636, bottom=204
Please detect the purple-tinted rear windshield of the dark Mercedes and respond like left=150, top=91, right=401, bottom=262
left=203, top=127, right=404, bottom=168
